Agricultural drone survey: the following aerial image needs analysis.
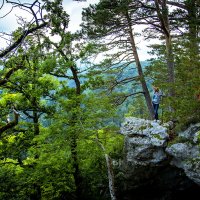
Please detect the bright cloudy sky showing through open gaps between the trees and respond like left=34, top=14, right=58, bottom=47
left=0, top=0, right=153, bottom=61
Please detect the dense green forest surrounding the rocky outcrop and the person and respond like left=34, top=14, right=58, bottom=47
left=0, top=0, right=200, bottom=200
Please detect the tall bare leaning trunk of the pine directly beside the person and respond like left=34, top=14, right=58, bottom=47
left=126, top=12, right=154, bottom=119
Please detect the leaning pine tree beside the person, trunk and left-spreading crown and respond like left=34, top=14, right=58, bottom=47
left=82, top=0, right=154, bottom=118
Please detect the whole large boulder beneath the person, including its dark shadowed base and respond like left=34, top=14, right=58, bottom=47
left=120, top=117, right=169, bottom=190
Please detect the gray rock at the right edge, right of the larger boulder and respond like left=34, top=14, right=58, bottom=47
left=166, top=123, right=200, bottom=185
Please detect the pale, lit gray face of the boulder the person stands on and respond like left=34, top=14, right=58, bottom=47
left=121, top=117, right=168, bottom=167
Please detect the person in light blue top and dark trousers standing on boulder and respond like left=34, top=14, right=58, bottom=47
left=152, top=86, right=162, bottom=120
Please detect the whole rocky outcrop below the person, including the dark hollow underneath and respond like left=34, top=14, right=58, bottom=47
left=120, top=117, right=200, bottom=200
